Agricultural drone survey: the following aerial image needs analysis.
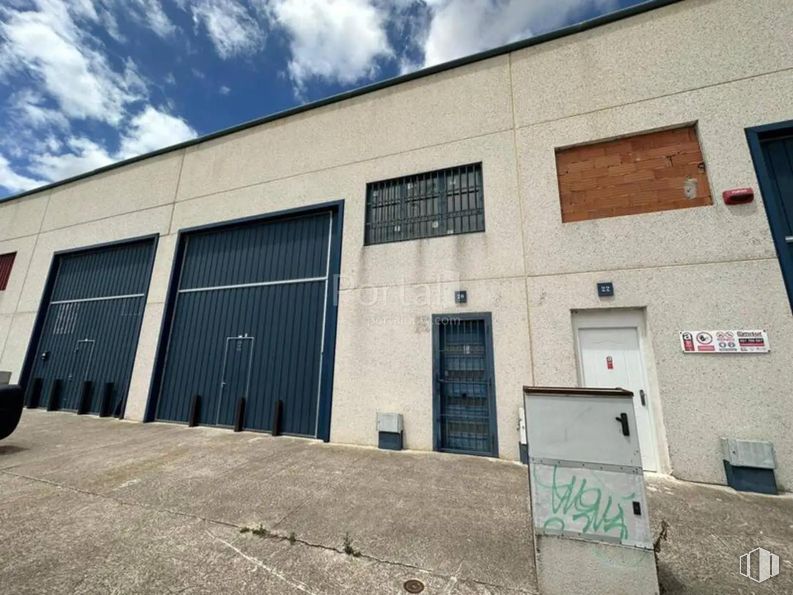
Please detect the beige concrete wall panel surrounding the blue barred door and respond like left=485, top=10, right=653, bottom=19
left=331, top=278, right=531, bottom=459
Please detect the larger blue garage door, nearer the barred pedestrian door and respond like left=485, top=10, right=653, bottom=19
left=155, top=211, right=336, bottom=436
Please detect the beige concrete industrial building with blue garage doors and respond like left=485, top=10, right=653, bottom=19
left=0, top=0, right=793, bottom=490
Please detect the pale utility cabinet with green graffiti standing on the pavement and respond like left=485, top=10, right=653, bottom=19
left=523, top=386, right=658, bottom=595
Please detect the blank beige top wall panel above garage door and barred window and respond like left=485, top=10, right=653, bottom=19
left=179, top=56, right=512, bottom=199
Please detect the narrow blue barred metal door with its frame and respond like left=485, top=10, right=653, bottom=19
left=434, top=315, right=498, bottom=456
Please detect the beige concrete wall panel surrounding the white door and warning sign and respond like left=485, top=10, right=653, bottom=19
left=528, top=260, right=793, bottom=487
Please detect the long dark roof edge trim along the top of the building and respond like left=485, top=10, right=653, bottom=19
left=0, top=0, right=683, bottom=204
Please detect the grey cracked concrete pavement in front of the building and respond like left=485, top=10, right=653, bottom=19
left=0, top=411, right=793, bottom=595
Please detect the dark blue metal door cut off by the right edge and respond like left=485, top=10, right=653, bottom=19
left=749, top=125, right=793, bottom=307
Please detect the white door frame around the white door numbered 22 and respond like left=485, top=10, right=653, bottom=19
left=571, top=308, right=667, bottom=473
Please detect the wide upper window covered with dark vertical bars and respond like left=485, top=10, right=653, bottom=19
left=365, top=163, right=485, bottom=245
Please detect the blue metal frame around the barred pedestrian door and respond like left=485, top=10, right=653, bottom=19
left=432, top=312, right=498, bottom=458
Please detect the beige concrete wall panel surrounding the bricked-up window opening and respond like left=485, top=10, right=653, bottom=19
left=510, top=63, right=793, bottom=275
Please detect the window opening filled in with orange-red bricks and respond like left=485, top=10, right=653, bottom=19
left=556, top=126, right=713, bottom=222
